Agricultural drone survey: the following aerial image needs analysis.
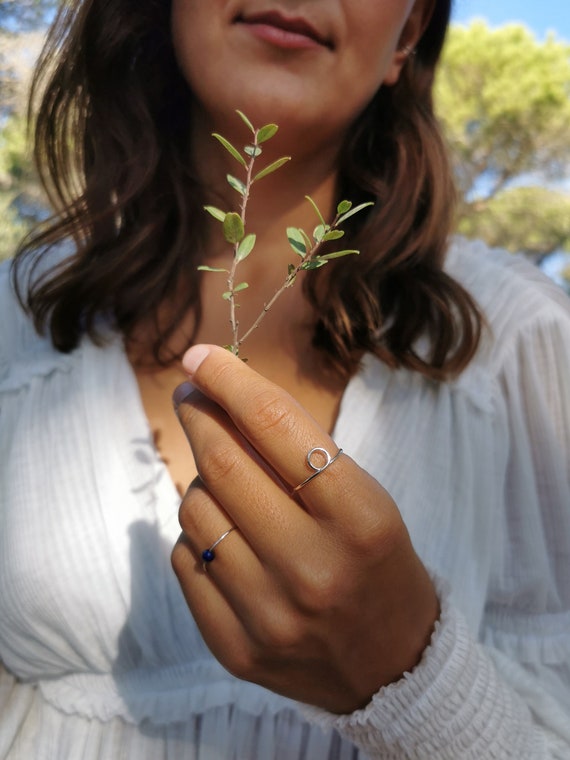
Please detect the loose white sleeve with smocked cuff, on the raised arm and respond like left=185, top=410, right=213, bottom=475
left=307, top=246, right=570, bottom=760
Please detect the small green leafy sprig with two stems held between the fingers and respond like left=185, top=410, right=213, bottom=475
left=198, top=111, right=373, bottom=356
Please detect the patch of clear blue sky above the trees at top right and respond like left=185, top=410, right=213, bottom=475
left=453, top=0, right=570, bottom=42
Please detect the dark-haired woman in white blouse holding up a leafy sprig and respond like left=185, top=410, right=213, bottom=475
left=0, top=0, right=570, bottom=760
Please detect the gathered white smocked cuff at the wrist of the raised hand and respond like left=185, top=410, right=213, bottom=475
left=303, top=580, right=544, bottom=760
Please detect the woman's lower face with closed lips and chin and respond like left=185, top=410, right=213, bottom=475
left=172, top=0, right=430, bottom=150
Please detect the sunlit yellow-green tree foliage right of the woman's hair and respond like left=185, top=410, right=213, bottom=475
left=436, top=22, right=570, bottom=259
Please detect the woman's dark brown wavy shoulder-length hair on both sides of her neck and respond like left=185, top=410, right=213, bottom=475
left=14, top=0, right=482, bottom=379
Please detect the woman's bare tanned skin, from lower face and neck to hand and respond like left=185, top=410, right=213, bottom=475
left=130, top=0, right=438, bottom=713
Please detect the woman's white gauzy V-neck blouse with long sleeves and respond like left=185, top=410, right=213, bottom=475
left=0, top=239, right=570, bottom=760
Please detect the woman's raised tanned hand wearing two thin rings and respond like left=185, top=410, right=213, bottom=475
left=172, top=346, right=439, bottom=713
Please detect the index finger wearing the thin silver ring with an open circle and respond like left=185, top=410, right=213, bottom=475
left=182, top=345, right=349, bottom=502
